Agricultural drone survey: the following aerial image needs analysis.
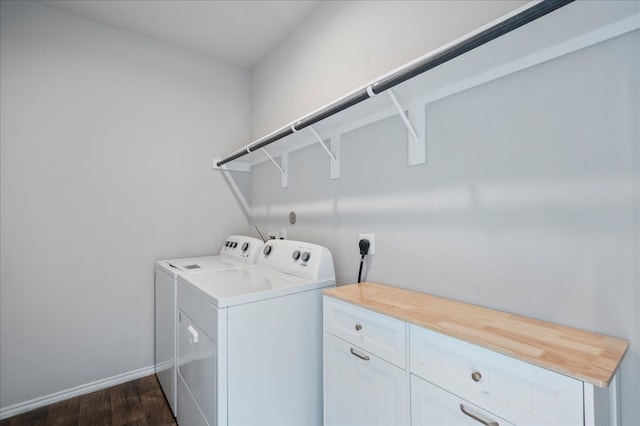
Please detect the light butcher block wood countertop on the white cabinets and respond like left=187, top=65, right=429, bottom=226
left=324, top=282, right=629, bottom=387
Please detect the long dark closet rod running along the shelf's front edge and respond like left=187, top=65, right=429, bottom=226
left=216, top=0, right=574, bottom=167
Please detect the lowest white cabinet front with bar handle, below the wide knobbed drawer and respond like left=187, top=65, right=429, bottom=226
left=411, top=375, right=513, bottom=426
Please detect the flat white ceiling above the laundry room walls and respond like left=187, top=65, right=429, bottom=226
left=40, top=0, right=320, bottom=69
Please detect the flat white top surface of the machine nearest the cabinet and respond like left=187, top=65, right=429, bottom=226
left=178, top=265, right=335, bottom=308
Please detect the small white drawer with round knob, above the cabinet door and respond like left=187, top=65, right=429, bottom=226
left=323, top=296, right=406, bottom=368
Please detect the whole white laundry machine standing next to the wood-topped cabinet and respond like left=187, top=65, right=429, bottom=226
left=178, top=240, right=335, bottom=426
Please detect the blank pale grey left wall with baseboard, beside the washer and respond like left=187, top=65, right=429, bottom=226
left=0, top=1, right=250, bottom=412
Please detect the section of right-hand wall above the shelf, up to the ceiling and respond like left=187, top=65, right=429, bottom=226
left=252, top=0, right=527, bottom=138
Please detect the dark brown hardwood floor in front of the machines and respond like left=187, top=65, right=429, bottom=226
left=0, top=375, right=176, bottom=426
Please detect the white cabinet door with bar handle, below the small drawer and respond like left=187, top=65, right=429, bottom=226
left=324, top=333, right=409, bottom=426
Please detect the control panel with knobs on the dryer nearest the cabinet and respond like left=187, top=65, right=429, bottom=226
left=257, top=240, right=335, bottom=280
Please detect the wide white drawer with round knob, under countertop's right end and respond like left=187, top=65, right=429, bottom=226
left=409, top=325, right=583, bottom=425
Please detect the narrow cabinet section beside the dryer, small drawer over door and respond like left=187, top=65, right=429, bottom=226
left=324, top=297, right=409, bottom=426
